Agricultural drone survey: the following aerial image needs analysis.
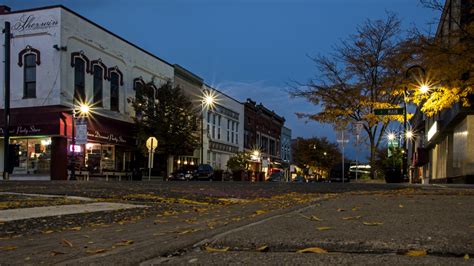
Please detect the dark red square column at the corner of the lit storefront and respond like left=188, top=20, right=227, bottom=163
left=51, top=137, right=68, bottom=180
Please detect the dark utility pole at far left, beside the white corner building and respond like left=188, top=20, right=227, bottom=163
left=3, top=21, right=11, bottom=180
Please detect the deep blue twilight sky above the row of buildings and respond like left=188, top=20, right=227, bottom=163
left=3, top=0, right=439, bottom=159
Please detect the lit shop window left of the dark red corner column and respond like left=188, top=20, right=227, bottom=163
left=10, top=138, right=51, bottom=175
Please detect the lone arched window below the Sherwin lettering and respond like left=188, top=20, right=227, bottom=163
left=18, top=45, right=41, bottom=99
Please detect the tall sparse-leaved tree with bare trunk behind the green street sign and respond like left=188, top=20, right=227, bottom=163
left=290, top=13, right=411, bottom=177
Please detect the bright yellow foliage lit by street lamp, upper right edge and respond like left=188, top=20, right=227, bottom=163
left=410, top=0, right=474, bottom=116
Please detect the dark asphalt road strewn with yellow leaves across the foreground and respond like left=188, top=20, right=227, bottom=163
left=0, top=182, right=474, bottom=265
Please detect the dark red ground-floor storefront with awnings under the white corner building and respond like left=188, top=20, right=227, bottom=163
left=0, top=106, right=135, bottom=180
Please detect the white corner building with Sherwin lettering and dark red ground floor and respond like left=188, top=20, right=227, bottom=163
left=0, top=6, right=174, bottom=179
